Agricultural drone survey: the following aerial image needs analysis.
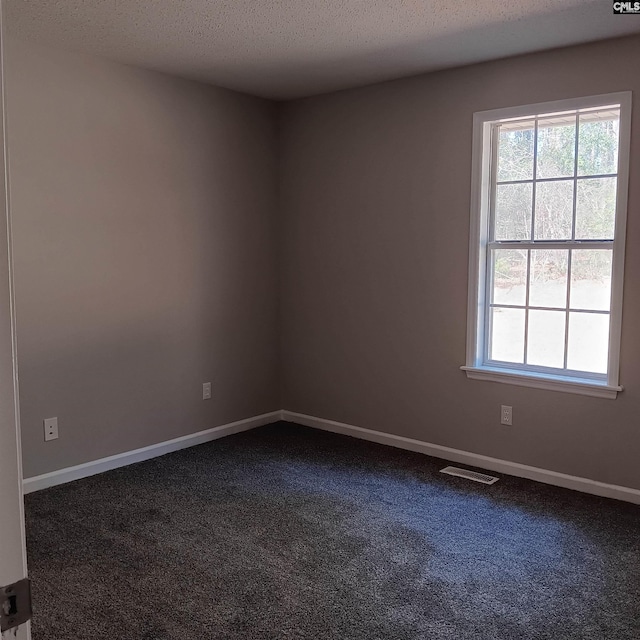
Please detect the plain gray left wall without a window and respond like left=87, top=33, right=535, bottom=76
left=7, top=40, right=280, bottom=477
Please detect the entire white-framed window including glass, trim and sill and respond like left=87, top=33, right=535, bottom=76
left=463, top=92, right=631, bottom=398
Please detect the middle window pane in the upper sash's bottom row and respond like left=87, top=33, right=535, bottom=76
left=535, top=180, right=573, bottom=240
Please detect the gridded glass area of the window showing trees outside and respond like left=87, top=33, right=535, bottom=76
left=487, top=106, right=620, bottom=374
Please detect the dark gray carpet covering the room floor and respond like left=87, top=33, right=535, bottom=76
left=26, top=423, right=640, bottom=640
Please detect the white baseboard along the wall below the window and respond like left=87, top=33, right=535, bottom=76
left=281, top=411, right=640, bottom=504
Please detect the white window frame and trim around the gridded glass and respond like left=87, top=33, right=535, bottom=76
left=461, top=91, right=631, bottom=399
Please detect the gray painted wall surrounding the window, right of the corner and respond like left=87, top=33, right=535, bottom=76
left=280, top=37, right=640, bottom=488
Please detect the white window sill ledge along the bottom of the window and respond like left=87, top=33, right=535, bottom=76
left=460, top=367, right=623, bottom=400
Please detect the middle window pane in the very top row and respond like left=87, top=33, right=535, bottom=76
left=536, top=115, right=576, bottom=178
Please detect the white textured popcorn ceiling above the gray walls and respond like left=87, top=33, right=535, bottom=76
left=4, top=0, right=640, bottom=99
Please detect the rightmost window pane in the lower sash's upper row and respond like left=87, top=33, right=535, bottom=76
left=570, top=249, right=613, bottom=311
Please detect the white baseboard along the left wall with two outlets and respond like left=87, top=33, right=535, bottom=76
left=22, top=411, right=282, bottom=493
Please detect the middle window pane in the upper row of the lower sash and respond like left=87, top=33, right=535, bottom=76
left=529, top=250, right=569, bottom=309
